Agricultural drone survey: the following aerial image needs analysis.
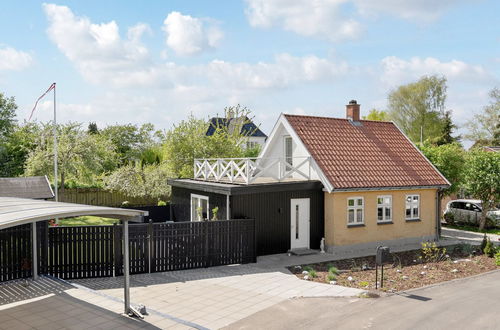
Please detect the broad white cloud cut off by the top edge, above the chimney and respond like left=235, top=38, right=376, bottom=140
left=245, top=0, right=470, bottom=41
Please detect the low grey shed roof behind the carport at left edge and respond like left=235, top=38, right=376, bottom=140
left=0, top=176, right=54, bottom=199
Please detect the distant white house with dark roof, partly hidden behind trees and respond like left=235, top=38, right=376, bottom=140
left=206, top=113, right=267, bottom=149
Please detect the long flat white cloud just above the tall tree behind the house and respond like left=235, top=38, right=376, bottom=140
left=380, top=56, right=492, bottom=86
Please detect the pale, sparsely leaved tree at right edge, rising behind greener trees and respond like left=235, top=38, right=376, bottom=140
left=464, top=87, right=500, bottom=145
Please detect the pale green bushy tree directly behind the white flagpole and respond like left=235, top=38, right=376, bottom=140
left=25, top=123, right=118, bottom=191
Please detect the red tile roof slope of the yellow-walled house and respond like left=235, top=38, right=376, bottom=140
left=285, top=115, right=448, bottom=189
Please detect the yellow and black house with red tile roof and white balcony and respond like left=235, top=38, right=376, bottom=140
left=169, top=101, right=449, bottom=255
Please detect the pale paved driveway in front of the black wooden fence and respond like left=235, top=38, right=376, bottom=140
left=75, top=255, right=362, bottom=329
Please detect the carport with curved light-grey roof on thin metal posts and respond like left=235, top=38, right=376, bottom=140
left=0, top=197, right=148, bottom=314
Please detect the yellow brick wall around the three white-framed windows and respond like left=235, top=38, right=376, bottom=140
left=325, top=189, right=437, bottom=246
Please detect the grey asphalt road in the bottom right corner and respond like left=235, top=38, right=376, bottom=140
left=228, top=271, right=500, bottom=330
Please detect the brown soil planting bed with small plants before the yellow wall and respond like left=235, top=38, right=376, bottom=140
left=289, top=244, right=500, bottom=292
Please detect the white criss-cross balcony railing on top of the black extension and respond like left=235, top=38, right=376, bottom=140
left=194, top=157, right=311, bottom=184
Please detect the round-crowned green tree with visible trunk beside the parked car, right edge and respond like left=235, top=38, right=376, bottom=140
left=464, top=149, right=500, bottom=230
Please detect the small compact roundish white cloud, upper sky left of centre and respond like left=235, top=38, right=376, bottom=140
left=163, top=11, right=223, bottom=55
